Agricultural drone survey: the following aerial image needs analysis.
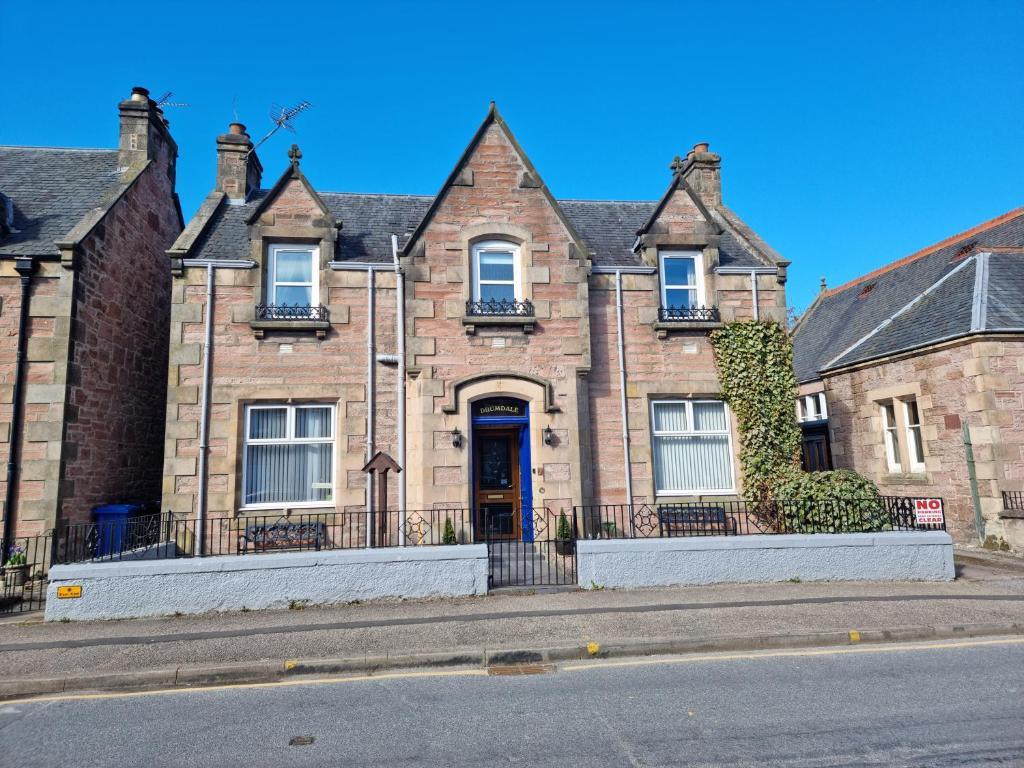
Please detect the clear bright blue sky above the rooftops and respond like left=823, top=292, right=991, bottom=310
left=0, top=0, right=1024, bottom=309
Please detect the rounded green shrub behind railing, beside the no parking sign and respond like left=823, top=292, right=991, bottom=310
left=772, top=469, right=890, bottom=534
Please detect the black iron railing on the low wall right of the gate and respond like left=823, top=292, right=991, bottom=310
left=573, top=497, right=946, bottom=539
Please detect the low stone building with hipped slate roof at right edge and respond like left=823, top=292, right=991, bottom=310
left=794, top=208, right=1024, bottom=550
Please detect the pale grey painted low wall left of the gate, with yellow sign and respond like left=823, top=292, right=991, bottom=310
left=46, top=544, right=487, bottom=622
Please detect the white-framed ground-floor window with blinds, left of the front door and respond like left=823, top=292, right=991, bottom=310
left=242, top=404, right=334, bottom=507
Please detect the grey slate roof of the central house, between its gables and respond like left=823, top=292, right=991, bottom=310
left=189, top=189, right=771, bottom=266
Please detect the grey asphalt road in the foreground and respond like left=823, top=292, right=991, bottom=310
left=0, top=638, right=1024, bottom=768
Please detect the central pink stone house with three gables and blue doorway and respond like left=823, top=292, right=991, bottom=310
left=163, top=105, right=787, bottom=537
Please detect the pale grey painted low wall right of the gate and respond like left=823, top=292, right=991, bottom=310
left=577, top=530, right=954, bottom=588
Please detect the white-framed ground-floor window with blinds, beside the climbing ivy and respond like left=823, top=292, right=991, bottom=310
left=651, top=400, right=735, bottom=496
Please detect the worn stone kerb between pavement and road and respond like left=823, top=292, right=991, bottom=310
left=0, top=623, right=1024, bottom=700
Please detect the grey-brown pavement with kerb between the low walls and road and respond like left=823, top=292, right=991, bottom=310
left=0, top=550, right=1024, bottom=698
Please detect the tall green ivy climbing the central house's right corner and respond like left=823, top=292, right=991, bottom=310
left=711, top=321, right=801, bottom=504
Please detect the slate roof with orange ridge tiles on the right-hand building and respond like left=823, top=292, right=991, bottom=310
left=794, top=208, right=1024, bottom=382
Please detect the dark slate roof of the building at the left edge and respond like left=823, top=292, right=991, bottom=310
left=0, top=146, right=120, bottom=256
